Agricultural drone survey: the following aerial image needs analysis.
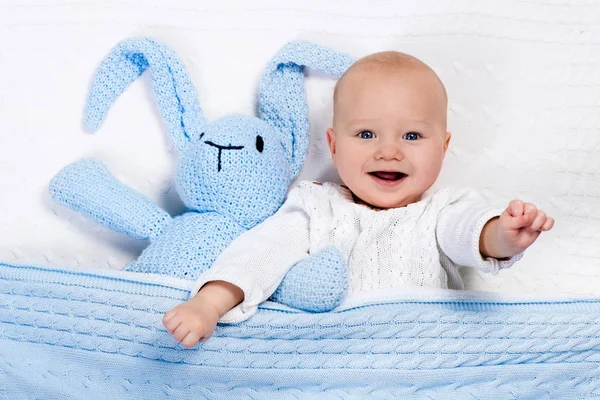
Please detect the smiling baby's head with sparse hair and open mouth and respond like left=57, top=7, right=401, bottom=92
left=327, top=51, right=450, bottom=208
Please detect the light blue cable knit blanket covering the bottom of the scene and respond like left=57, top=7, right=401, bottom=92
left=0, top=264, right=600, bottom=400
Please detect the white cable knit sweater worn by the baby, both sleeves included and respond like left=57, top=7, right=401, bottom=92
left=192, top=182, right=522, bottom=322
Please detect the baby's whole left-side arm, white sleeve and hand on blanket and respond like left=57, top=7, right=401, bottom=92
left=163, top=184, right=309, bottom=347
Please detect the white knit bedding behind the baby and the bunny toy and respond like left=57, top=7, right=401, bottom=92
left=0, top=0, right=600, bottom=295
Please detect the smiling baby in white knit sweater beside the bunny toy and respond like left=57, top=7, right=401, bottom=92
left=163, top=52, right=554, bottom=347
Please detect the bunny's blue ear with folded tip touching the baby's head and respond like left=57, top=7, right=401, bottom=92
left=258, top=41, right=355, bottom=179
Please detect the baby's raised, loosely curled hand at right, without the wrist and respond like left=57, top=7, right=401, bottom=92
left=498, top=200, right=554, bottom=255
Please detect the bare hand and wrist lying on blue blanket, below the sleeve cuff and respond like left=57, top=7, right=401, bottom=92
left=163, top=281, right=244, bottom=347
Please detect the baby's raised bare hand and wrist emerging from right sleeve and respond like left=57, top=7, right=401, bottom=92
left=479, top=200, right=554, bottom=258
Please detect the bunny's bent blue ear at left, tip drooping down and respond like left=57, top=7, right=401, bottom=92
left=84, top=38, right=205, bottom=150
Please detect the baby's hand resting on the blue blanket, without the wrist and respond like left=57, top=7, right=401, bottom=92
left=163, top=296, right=220, bottom=348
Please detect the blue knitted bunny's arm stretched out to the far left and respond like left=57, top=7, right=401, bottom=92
left=50, top=158, right=171, bottom=240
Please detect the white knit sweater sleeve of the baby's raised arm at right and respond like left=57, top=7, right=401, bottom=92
left=436, top=188, right=523, bottom=275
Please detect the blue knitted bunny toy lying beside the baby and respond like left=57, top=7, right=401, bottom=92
left=50, top=38, right=354, bottom=312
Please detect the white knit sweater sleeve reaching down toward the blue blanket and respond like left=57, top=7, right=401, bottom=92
left=191, top=187, right=309, bottom=323
